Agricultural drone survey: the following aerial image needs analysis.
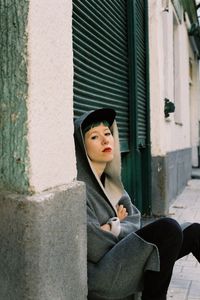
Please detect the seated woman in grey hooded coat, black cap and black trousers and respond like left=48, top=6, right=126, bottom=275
left=75, top=108, right=200, bottom=300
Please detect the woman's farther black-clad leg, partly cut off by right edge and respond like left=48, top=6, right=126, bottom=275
left=178, top=223, right=200, bottom=262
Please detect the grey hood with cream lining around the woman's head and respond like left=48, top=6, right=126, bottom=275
left=74, top=111, right=124, bottom=210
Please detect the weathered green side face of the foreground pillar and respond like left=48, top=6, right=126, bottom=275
left=0, top=0, right=29, bottom=193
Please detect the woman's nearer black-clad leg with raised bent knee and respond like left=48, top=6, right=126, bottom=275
left=136, top=218, right=183, bottom=300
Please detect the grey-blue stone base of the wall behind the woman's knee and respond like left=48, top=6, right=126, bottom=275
left=152, top=148, right=192, bottom=216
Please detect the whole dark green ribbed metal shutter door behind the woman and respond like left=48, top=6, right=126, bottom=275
left=73, top=0, right=151, bottom=211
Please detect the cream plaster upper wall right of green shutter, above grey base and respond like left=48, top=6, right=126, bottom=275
left=149, top=1, right=190, bottom=156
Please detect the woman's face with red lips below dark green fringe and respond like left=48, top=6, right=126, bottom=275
left=85, top=123, right=114, bottom=163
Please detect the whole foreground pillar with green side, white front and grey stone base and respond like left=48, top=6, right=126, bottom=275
left=0, top=0, right=87, bottom=300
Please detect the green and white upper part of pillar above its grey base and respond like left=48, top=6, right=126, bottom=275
left=0, top=0, right=76, bottom=193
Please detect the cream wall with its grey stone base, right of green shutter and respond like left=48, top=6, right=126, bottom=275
left=149, top=1, right=200, bottom=215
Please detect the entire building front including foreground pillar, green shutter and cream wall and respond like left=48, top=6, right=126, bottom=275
left=0, top=0, right=200, bottom=300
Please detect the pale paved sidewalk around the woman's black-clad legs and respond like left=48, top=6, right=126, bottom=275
left=167, top=178, right=200, bottom=300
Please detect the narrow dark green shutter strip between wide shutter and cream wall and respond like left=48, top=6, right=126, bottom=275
left=123, top=0, right=151, bottom=214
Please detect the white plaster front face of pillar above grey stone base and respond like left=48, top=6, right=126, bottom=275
left=28, top=0, right=76, bottom=192
